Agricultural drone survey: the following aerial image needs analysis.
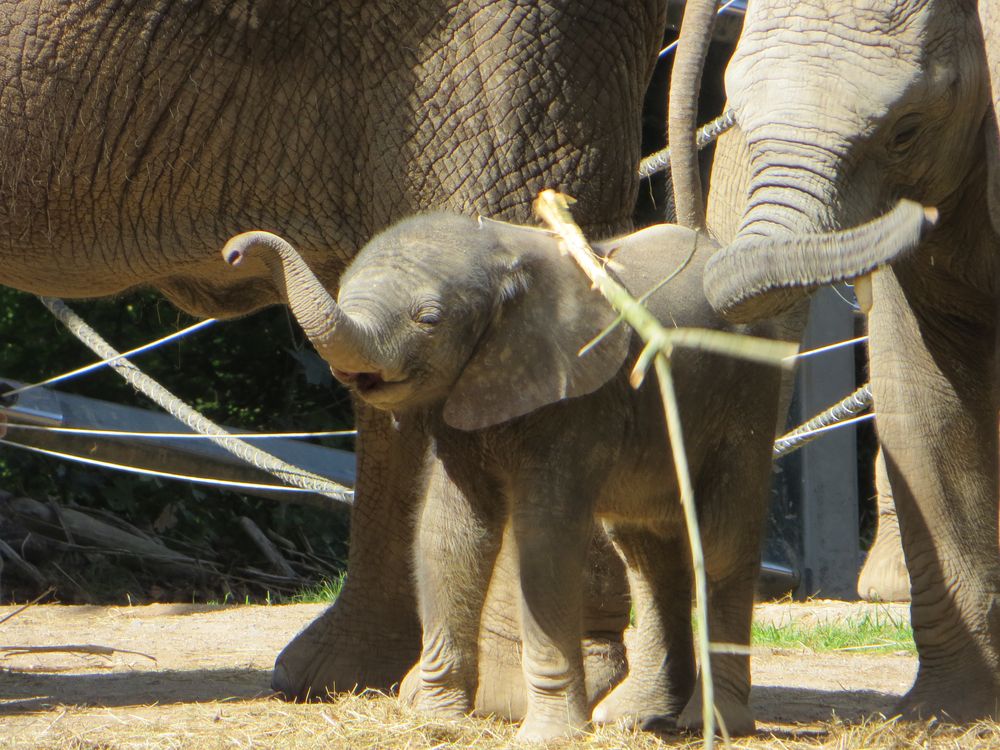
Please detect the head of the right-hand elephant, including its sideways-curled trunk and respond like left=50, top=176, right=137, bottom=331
left=705, top=0, right=985, bottom=321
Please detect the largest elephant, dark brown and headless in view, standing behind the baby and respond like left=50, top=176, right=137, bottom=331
left=0, top=0, right=665, bottom=710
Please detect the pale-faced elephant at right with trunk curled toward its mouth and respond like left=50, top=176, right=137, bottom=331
left=678, top=0, right=1000, bottom=720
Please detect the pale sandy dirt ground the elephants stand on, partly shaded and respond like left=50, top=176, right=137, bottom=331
left=0, top=602, right=916, bottom=749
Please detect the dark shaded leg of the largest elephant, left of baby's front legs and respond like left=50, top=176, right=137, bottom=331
left=271, top=400, right=427, bottom=700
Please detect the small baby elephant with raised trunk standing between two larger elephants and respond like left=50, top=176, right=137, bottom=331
left=223, top=214, right=779, bottom=740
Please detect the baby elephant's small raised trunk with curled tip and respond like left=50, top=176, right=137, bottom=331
left=222, top=231, right=377, bottom=372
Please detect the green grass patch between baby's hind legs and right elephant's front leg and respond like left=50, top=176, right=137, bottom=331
left=750, top=612, right=916, bottom=653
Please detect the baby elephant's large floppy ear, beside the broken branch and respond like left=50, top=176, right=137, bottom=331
left=444, top=225, right=631, bottom=430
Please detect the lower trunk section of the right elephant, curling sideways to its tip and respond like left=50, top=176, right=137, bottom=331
left=705, top=200, right=938, bottom=323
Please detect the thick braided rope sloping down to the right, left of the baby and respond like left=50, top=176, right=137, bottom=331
left=39, top=297, right=354, bottom=503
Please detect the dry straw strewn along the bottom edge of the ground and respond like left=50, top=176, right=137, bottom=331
left=0, top=693, right=1000, bottom=750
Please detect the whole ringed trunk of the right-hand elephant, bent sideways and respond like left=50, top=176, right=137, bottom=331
left=704, top=137, right=937, bottom=323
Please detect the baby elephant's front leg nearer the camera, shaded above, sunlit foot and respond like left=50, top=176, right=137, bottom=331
left=513, top=503, right=591, bottom=741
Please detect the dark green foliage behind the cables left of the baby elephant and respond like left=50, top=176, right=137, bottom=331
left=0, top=288, right=353, bottom=600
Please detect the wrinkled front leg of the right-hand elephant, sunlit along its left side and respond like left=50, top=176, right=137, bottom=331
left=870, top=262, right=1000, bottom=721
